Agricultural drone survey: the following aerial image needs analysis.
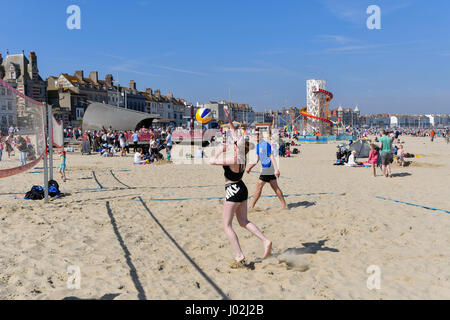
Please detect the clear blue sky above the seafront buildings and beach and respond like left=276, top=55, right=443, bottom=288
left=0, top=0, right=450, bottom=114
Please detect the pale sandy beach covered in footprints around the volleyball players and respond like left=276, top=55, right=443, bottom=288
left=0, top=137, right=450, bottom=300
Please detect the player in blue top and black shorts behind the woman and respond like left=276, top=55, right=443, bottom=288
left=247, top=131, right=288, bottom=209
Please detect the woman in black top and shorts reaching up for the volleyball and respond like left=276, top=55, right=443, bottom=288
left=210, top=109, right=272, bottom=264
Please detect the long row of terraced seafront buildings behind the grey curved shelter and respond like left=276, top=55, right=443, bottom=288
left=47, top=70, right=186, bottom=126
